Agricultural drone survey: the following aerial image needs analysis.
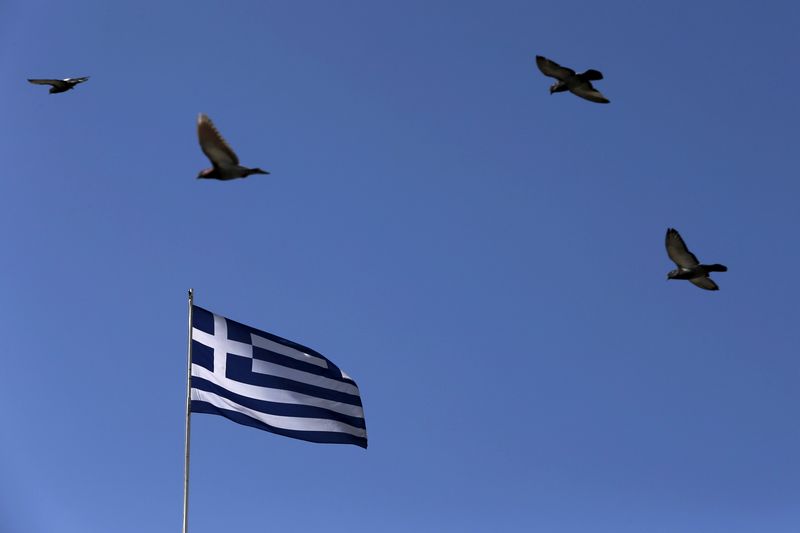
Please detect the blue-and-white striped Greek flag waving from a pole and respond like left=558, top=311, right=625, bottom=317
left=191, top=305, right=367, bottom=448
